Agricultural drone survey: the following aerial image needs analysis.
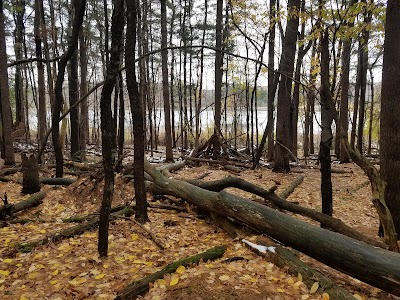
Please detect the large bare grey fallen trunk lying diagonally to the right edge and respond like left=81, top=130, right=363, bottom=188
left=145, top=161, right=400, bottom=296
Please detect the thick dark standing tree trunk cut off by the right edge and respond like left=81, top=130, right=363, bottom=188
left=380, top=0, right=400, bottom=235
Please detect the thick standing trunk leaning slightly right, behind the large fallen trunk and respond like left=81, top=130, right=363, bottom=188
left=273, top=0, right=300, bottom=173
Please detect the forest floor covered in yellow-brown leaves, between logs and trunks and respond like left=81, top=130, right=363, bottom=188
left=0, top=152, right=398, bottom=300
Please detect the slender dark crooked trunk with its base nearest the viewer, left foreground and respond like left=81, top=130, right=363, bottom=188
left=97, top=0, right=125, bottom=257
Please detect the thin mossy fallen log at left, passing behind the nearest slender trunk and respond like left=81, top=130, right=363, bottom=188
left=3, top=206, right=133, bottom=257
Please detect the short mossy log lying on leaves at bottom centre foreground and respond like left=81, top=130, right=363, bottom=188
left=115, top=246, right=226, bottom=300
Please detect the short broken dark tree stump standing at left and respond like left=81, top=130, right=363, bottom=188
left=21, top=154, right=40, bottom=194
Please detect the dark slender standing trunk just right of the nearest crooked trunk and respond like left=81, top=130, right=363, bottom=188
left=125, top=0, right=149, bottom=224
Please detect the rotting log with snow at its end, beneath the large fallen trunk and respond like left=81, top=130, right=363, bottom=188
left=252, top=237, right=356, bottom=300
